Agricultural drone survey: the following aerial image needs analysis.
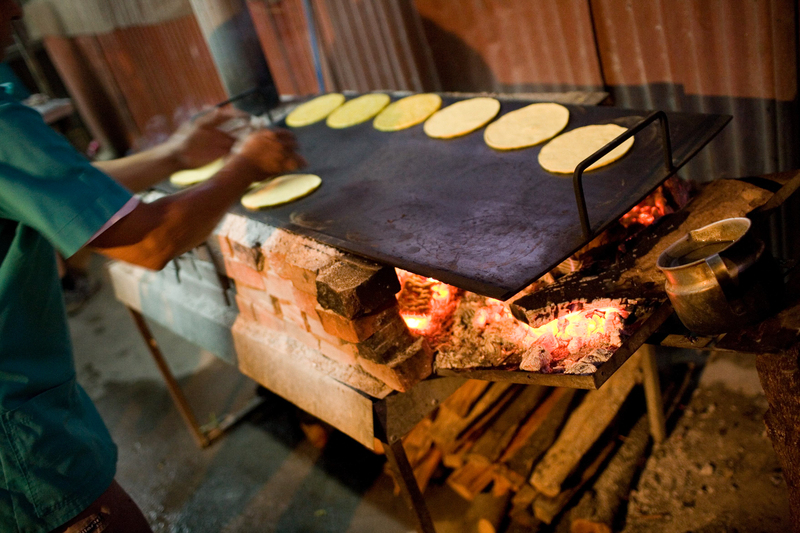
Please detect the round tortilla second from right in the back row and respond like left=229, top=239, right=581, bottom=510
left=483, top=104, right=569, bottom=150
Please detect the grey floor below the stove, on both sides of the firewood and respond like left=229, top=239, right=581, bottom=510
left=70, top=259, right=788, bottom=533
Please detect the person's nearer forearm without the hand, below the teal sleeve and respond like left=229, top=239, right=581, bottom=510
left=90, top=157, right=263, bottom=270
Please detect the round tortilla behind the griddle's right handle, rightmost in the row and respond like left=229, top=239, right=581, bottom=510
left=539, top=124, right=633, bottom=174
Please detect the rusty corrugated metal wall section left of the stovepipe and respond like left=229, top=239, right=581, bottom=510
left=44, top=16, right=226, bottom=154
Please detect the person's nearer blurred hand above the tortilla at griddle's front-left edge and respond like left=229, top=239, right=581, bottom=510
left=236, top=129, right=306, bottom=175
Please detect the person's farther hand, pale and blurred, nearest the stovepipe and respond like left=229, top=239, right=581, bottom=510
left=166, top=109, right=249, bottom=169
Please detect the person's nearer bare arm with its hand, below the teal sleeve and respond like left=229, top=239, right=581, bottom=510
left=89, top=130, right=305, bottom=270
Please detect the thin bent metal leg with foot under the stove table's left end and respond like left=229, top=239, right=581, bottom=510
left=128, top=307, right=264, bottom=448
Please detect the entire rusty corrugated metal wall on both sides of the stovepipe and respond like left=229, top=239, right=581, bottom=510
left=39, top=0, right=800, bottom=191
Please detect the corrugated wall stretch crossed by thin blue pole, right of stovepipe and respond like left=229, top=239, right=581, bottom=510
left=248, top=0, right=439, bottom=94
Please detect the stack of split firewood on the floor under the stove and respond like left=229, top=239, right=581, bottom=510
left=388, top=356, right=682, bottom=532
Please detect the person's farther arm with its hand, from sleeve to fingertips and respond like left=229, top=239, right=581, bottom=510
left=93, top=109, right=242, bottom=192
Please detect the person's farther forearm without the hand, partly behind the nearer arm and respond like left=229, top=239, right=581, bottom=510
left=93, top=143, right=182, bottom=192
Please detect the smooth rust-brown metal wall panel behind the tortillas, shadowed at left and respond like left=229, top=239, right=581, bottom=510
left=414, top=0, right=603, bottom=93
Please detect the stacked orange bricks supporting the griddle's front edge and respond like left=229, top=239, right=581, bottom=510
left=216, top=215, right=432, bottom=393
